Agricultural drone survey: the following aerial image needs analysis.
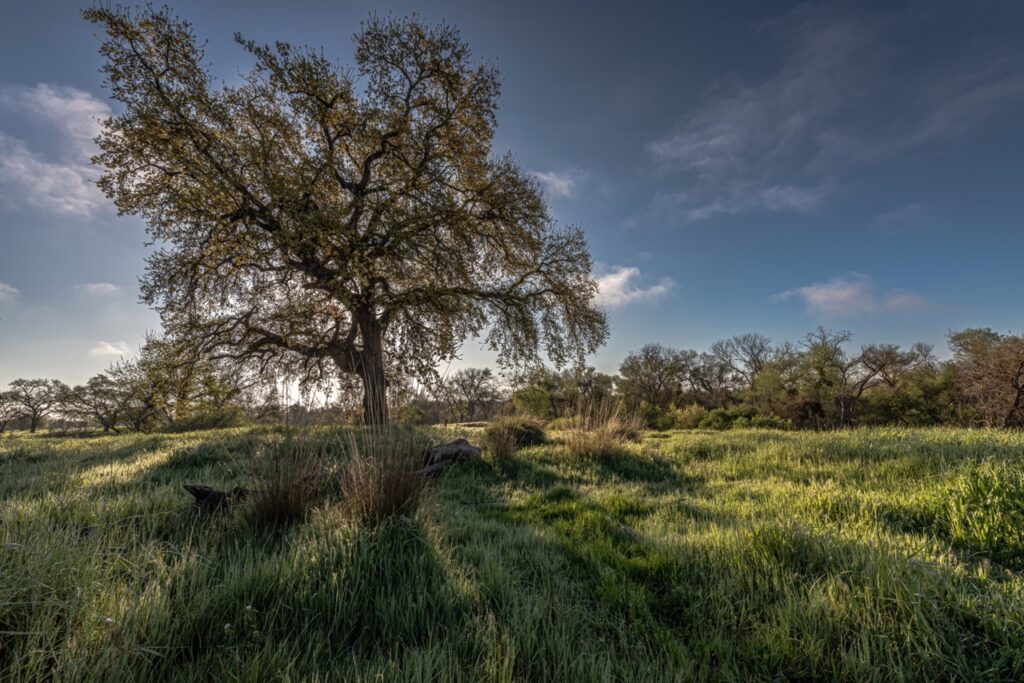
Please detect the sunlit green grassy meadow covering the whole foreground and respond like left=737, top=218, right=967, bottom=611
left=0, top=429, right=1024, bottom=681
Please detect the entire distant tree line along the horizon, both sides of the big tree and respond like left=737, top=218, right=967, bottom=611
left=0, top=328, right=1024, bottom=433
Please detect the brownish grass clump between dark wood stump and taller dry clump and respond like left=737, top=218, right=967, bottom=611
left=249, top=435, right=333, bottom=527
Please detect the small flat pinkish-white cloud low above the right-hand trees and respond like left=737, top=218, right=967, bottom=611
left=772, top=272, right=926, bottom=317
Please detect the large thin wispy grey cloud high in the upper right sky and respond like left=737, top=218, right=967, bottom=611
left=647, top=7, right=1024, bottom=221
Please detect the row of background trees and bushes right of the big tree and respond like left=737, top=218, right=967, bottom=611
left=503, top=328, right=1024, bottom=429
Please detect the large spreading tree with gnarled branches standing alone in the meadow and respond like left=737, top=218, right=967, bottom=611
left=84, top=8, right=606, bottom=422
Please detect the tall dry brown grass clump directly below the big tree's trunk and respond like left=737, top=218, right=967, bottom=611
left=340, top=427, right=430, bottom=526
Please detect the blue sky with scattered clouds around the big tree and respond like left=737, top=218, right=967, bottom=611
left=0, top=0, right=1024, bottom=385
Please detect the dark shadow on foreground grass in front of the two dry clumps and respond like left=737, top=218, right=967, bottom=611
left=133, top=518, right=484, bottom=680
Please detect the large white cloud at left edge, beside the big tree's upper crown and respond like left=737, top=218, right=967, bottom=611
left=0, top=83, right=111, bottom=216
